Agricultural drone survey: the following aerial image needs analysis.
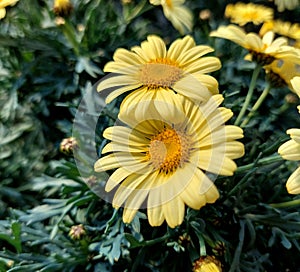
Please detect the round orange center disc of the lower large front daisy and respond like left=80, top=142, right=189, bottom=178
left=147, top=128, right=190, bottom=174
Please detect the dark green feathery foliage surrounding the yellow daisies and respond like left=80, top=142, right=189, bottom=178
left=0, top=0, right=300, bottom=272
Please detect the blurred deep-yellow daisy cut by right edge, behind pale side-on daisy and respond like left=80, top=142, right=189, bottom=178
left=259, top=20, right=300, bottom=48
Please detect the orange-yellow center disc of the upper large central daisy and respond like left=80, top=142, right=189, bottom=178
left=140, top=59, right=183, bottom=88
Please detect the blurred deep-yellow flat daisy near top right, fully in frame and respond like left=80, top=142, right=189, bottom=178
left=225, top=2, right=274, bottom=26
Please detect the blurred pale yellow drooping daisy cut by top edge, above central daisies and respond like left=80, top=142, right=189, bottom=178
left=150, top=0, right=193, bottom=35
